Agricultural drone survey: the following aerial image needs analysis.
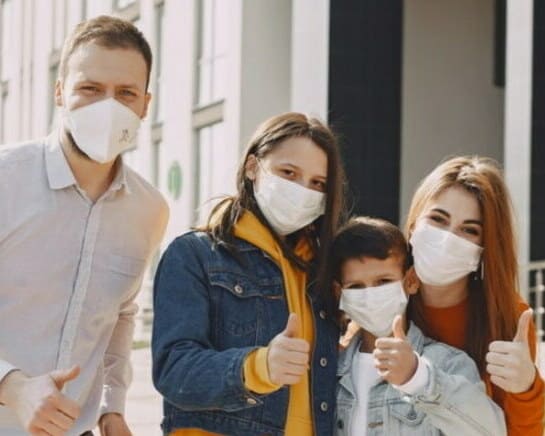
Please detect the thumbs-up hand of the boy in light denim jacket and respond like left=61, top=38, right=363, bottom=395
left=373, top=315, right=418, bottom=385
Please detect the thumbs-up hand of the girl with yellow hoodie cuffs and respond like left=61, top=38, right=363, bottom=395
left=267, top=313, right=310, bottom=385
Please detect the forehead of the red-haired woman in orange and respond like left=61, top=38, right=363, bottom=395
left=426, top=186, right=481, bottom=221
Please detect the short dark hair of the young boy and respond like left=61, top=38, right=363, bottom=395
left=329, top=216, right=410, bottom=281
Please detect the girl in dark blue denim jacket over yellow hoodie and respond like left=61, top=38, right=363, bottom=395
left=152, top=113, right=343, bottom=436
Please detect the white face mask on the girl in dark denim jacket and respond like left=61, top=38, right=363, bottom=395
left=254, top=168, right=325, bottom=235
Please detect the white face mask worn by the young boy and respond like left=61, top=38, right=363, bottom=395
left=339, top=281, right=408, bottom=338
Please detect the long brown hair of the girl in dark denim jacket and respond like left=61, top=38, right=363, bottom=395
left=201, top=112, right=345, bottom=302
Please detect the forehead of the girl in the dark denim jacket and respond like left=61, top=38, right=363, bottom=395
left=265, top=136, right=327, bottom=177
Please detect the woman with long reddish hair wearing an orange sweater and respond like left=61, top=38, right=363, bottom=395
left=406, top=157, right=544, bottom=436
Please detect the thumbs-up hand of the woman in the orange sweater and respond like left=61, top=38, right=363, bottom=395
left=486, top=309, right=536, bottom=394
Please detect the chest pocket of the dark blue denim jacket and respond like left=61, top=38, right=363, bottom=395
left=209, top=271, right=284, bottom=349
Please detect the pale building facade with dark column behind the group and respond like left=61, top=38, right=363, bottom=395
left=0, top=0, right=545, bottom=338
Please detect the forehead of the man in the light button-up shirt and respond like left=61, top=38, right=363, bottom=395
left=66, top=42, right=147, bottom=88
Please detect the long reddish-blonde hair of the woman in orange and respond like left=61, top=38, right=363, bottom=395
left=405, top=156, right=519, bottom=372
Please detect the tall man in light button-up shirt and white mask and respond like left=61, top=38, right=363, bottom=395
left=0, top=16, right=168, bottom=436
